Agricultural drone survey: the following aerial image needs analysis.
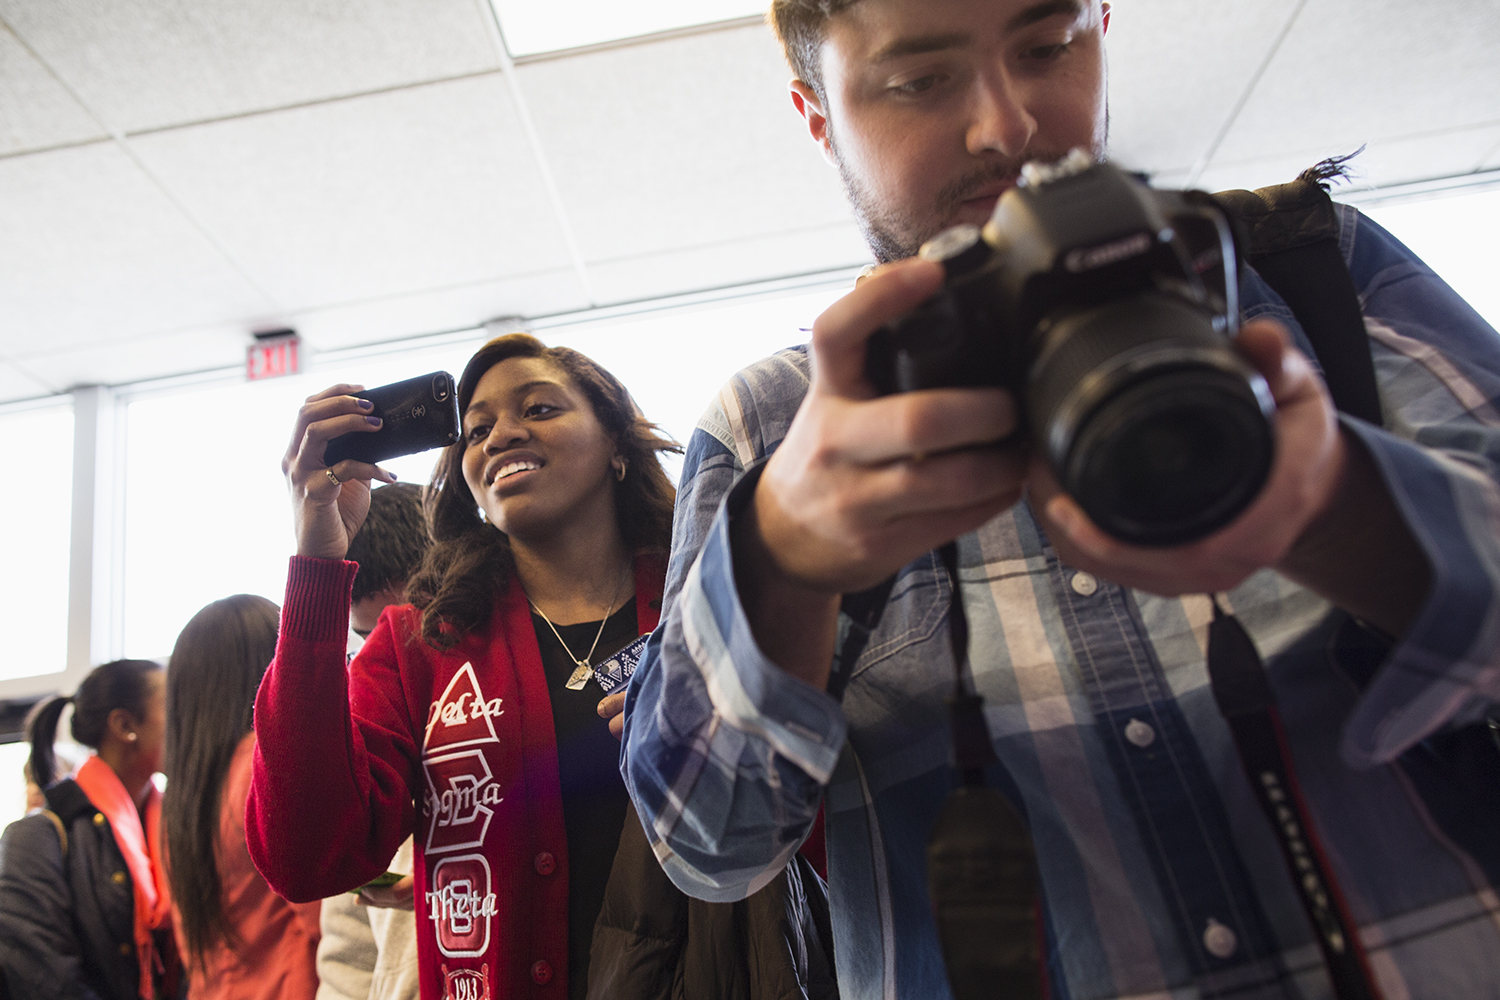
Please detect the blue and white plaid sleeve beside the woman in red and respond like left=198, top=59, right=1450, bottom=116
left=621, top=350, right=846, bottom=901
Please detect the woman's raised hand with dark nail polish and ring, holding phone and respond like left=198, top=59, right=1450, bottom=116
left=282, top=385, right=396, bottom=559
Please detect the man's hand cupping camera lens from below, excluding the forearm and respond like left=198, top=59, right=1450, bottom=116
left=1029, top=319, right=1349, bottom=597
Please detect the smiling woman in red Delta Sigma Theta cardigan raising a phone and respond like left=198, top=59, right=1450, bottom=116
left=246, top=334, right=677, bottom=1000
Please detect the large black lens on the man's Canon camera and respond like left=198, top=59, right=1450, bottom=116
left=1028, top=294, right=1274, bottom=546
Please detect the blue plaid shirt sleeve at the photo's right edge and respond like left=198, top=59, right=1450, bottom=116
left=1341, top=208, right=1500, bottom=765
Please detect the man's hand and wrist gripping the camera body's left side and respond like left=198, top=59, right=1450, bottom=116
left=734, top=259, right=1026, bottom=685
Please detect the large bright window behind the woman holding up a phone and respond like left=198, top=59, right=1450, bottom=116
left=117, top=286, right=845, bottom=660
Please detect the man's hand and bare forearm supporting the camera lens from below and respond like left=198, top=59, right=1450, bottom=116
left=1029, top=321, right=1430, bottom=636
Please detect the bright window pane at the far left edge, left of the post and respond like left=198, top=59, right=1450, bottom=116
left=0, top=405, right=74, bottom=681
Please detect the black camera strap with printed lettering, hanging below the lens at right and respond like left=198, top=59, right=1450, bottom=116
left=1208, top=597, right=1382, bottom=1000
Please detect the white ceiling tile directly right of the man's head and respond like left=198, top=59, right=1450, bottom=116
left=1104, top=0, right=1296, bottom=172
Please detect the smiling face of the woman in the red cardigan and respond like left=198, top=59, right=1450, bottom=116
left=464, top=358, right=615, bottom=543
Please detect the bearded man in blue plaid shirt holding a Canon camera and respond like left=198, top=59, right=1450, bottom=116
left=623, top=0, right=1500, bottom=1000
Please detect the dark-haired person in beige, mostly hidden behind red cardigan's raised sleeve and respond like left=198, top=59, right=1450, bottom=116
left=318, top=483, right=428, bottom=1000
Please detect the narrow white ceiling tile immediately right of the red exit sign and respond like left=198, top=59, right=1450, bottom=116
left=288, top=268, right=590, bottom=351
